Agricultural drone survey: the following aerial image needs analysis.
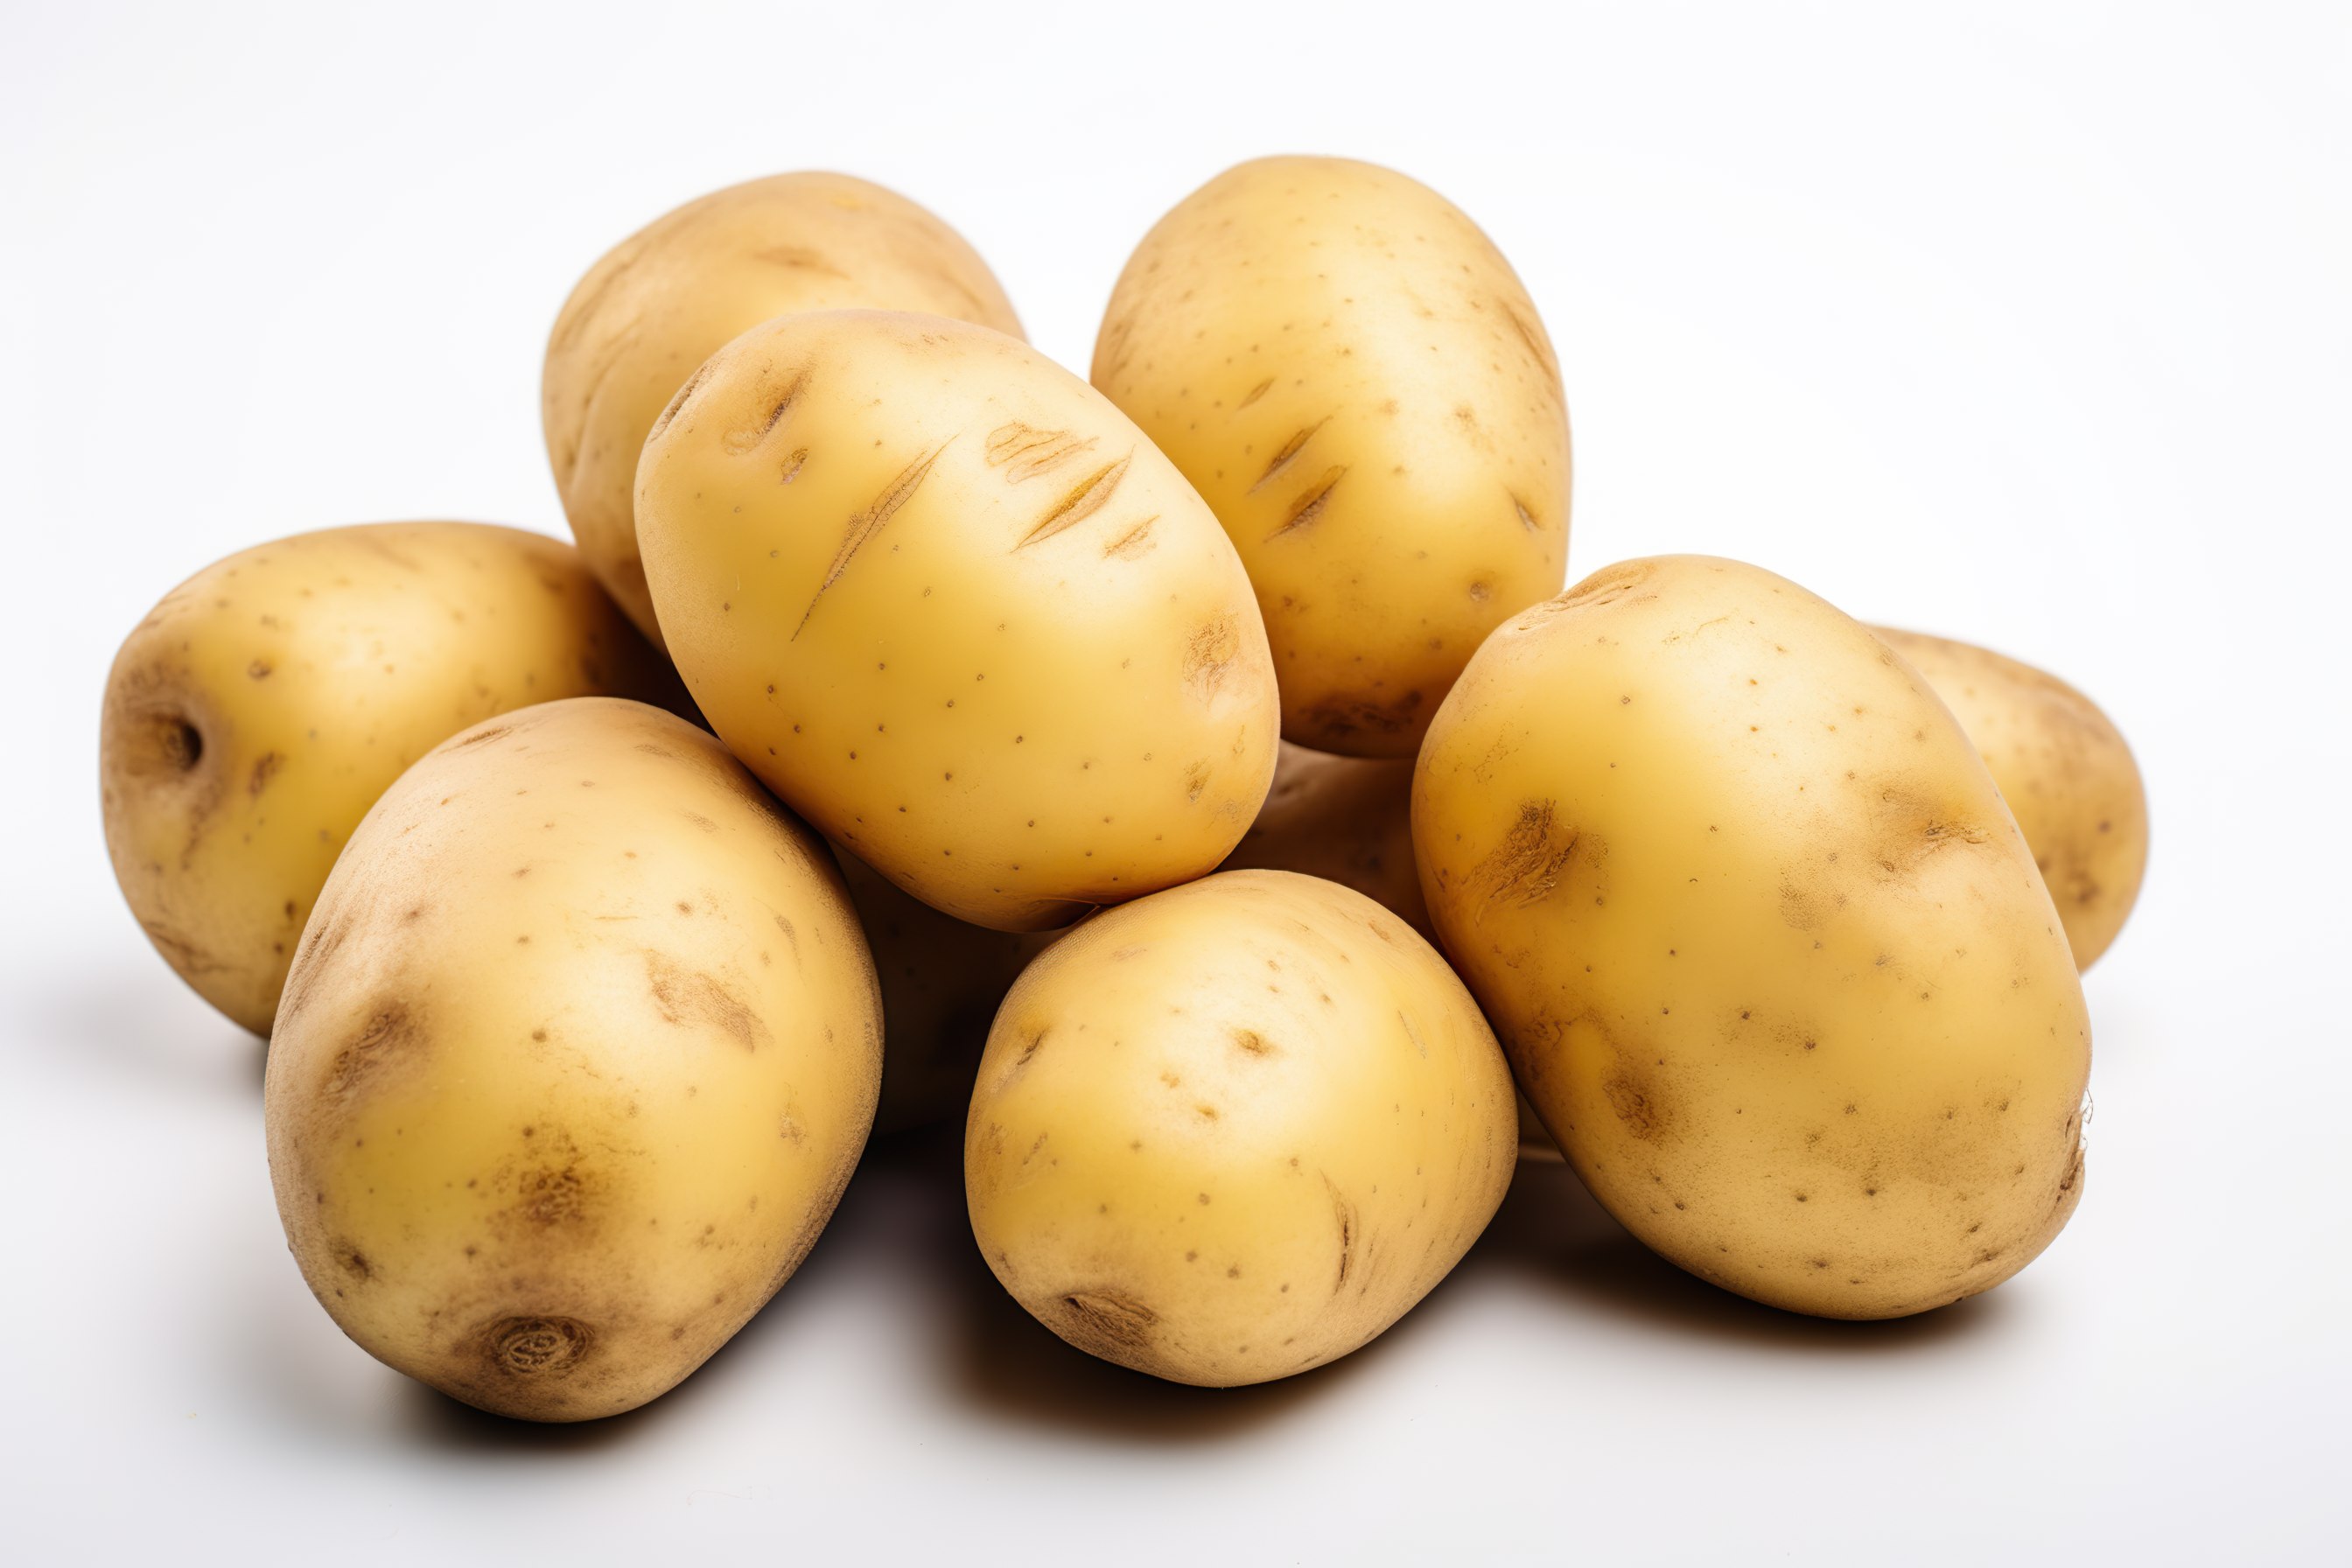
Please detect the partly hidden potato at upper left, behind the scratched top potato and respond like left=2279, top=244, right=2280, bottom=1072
left=555, top=174, right=1021, bottom=644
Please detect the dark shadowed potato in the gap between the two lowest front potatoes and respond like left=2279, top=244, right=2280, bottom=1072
left=833, top=849, right=1059, bottom=1133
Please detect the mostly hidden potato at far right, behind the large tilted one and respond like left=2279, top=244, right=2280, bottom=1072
left=1874, top=626, right=2147, bottom=969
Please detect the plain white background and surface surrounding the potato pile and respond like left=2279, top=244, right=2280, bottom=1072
left=0, top=0, right=2352, bottom=1564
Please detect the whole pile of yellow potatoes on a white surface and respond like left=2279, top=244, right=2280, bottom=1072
left=102, top=158, right=2147, bottom=1420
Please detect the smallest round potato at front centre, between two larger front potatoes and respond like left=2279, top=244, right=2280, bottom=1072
left=964, top=872, right=1517, bottom=1387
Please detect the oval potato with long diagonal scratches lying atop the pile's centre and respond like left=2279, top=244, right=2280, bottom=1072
left=637, top=311, right=1278, bottom=931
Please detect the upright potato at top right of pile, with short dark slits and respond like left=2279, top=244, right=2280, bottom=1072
left=1094, top=158, right=1569, bottom=757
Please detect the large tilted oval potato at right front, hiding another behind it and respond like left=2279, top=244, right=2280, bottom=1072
left=1413, top=557, right=2091, bottom=1319
